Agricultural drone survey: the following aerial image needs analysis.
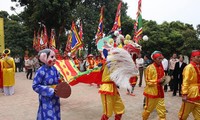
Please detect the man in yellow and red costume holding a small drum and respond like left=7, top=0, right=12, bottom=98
left=142, top=51, right=166, bottom=120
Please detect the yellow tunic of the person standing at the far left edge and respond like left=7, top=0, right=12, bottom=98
left=2, top=57, right=15, bottom=87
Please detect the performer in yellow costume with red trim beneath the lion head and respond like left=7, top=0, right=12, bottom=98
left=99, top=65, right=125, bottom=120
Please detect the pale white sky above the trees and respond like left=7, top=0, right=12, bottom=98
left=0, top=0, right=200, bottom=28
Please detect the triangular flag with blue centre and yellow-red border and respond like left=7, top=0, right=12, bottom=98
left=71, top=22, right=82, bottom=54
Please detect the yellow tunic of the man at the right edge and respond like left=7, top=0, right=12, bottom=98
left=182, top=64, right=200, bottom=101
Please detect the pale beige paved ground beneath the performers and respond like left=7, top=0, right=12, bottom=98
left=0, top=72, right=193, bottom=120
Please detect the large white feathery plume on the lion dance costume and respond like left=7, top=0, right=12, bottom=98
left=106, top=48, right=138, bottom=89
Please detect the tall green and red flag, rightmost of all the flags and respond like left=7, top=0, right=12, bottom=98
left=133, top=0, right=142, bottom=43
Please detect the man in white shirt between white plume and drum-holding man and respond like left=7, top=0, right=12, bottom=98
left=135, top=54, right=144, bottom=87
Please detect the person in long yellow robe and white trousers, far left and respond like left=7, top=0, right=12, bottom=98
left=2, top=49, right=15, bottom=96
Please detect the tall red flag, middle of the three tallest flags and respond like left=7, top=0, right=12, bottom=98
left=111, top=1, right=122, bottom=33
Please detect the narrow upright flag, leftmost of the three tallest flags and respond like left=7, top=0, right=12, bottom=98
left=95, top=7, right=104, bottom=44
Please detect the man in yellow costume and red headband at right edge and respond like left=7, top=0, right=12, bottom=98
left=179, top=50, right=200, bottom=120
